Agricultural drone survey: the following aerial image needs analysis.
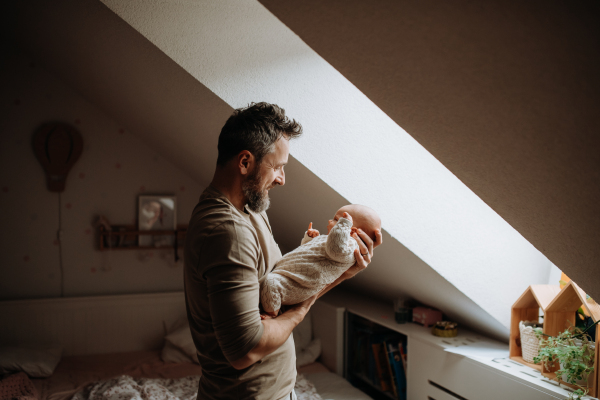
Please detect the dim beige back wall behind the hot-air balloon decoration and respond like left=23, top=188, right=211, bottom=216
left=0, top=54, right=201, bottom=299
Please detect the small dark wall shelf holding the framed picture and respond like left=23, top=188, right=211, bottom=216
left=99, top=225, right=187, bottom=251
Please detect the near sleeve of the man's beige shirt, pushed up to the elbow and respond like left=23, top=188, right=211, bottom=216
left=202, top=221, right=264, bottom=362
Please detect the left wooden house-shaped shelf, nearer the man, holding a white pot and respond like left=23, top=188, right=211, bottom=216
left=509, top=285, right=560, bottom=372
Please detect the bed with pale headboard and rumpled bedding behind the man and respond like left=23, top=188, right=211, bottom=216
left=0, top=292, right=370, bottom=400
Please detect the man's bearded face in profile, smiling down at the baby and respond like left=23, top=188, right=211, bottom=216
left=242, top=136, right=290, bottom=213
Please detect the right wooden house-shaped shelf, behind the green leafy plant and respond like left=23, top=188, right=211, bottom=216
left=544, top=281, right=600, bottom=397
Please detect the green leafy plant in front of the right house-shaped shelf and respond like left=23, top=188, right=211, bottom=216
left=533, top=321, right=600, bottom=400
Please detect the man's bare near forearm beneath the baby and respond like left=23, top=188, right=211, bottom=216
left=231, top=307, right=308, bottom=369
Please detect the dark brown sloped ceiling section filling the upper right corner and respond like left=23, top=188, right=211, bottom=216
left=260, top=0, right=600, bottom=304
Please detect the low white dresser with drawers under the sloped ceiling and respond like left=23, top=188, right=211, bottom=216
left=319, top=289, right=592, bottom=400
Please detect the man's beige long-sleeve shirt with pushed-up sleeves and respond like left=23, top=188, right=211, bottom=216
left=184, top=186, right=296, bottom=400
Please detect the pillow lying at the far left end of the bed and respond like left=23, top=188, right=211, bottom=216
left=0, top=347, right=62, bottom=378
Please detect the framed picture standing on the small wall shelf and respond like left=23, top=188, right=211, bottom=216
left=138, top=196, right=177, bottom=247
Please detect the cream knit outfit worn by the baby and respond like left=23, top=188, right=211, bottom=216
left=260, top=218, right=358, bottom=312
